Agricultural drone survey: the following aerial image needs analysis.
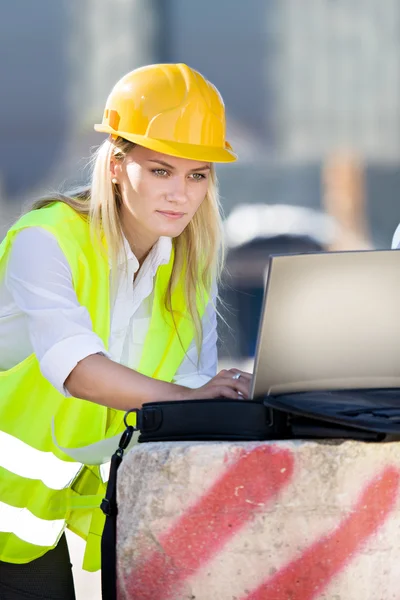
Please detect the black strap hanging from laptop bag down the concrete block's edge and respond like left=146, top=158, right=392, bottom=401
left=100, top=409, right=138, bottom=600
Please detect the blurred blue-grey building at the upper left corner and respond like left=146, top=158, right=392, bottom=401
left=0, top=0, right=71, bottom=197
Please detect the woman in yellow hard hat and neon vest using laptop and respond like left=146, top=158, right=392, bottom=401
left=0, top=65, right=250, bottom=600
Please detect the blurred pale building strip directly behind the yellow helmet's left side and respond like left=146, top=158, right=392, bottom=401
left=68, top=0, right=159, bottom=133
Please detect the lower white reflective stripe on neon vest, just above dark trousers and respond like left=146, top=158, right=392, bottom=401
left=0, top=502, right=65, bottom=547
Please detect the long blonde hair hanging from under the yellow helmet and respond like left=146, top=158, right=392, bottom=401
left=32, top=137, right=224, bottom=350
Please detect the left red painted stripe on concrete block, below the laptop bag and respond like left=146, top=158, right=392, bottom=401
left=120, top=445, right=294, bottom=600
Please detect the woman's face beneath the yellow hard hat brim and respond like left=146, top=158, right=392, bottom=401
left=111, top=146, right=211, bottom=248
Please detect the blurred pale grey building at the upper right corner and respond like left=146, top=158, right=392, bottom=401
left=274, top=0, right=400, bottom=163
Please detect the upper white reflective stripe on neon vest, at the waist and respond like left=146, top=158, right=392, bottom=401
left=0, top=431, right=83, bottom=490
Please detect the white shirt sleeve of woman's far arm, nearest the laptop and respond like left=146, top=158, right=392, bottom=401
left=174, top=286, right=218, bottom=388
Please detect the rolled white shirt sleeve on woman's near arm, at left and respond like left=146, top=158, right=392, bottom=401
left=5, top=227, right=108, bottom=396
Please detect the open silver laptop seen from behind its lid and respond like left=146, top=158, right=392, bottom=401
left=251, top=250, right=400, bottom=398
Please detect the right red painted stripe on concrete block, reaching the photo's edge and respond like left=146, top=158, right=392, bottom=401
left=242, top=467, right=400, bottom=600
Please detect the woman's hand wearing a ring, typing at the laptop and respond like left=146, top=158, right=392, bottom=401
left=182, top=369, right=252, bottom=400
